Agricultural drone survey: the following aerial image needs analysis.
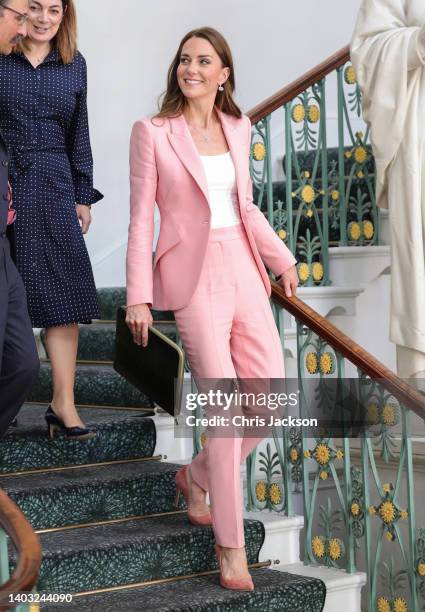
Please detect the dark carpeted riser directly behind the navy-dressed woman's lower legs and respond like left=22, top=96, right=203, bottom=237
left=28, top=362, right=150, bottom=408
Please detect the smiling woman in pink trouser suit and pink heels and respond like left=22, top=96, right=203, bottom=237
left=127, top=28, right=298, bottom=590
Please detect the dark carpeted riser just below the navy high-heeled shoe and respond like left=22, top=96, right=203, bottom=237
left=0, top=417, right=156, bottom=474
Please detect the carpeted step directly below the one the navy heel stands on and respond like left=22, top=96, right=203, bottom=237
left=0, top=460, right=179, bottom=529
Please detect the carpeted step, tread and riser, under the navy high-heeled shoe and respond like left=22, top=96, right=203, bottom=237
left=0, top=405, right=156, bottom=474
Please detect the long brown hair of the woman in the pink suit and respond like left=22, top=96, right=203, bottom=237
left=155, top=27, right=242, bottom=118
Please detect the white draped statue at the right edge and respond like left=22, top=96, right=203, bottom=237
left=351, top=0, right=425, bottom=389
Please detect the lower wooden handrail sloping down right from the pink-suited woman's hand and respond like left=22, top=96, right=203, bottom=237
left=272, top=282, right=425, bottom=419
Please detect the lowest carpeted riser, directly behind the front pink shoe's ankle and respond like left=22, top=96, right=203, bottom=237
left=24, top=522, right=263, bottom=593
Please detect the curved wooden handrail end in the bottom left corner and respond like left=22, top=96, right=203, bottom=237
left=0, top=489, right=41, bottom=611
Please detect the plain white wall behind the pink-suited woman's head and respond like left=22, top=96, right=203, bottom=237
left=76, top=0, right=359, bottom=286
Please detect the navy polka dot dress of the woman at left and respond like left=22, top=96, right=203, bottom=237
left=0, top=50, right=103, bottom=327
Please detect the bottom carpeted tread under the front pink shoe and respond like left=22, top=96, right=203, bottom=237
left=43, top=568, right=326, bottom=612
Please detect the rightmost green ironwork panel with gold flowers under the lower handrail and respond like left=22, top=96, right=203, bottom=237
left=359, top=372, right=422, bottom=611
